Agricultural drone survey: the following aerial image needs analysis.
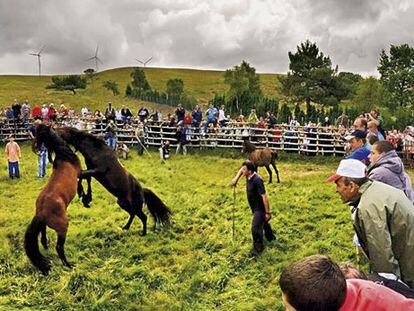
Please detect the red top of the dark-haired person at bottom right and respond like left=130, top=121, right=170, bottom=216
left=340, top=279, right=414, bottom=311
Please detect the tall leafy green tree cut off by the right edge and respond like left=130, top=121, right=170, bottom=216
left=378, top=44, right=414, bottom=107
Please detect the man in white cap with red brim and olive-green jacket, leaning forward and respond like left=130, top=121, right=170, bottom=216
left=327, top=159, right=414, bottom=288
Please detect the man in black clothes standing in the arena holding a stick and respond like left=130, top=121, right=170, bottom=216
left=232, top=161, right=276, bottom=256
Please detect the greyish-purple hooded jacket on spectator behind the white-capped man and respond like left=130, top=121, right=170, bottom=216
left=368, top=150, right=414, bottom=204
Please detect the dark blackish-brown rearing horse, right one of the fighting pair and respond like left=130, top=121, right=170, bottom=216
left=57, top=127, right=171, bottom=235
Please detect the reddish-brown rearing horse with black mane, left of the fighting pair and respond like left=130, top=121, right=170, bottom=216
left=24, top=124, right=81, bottom=275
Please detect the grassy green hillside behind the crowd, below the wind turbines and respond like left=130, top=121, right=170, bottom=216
left=0, top=67, right=279, bottom=112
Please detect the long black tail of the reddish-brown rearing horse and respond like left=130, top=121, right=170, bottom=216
left=24, top=216, right=50, bottom=275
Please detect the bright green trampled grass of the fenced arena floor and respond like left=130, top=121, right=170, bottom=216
left=0, top=145, right=413, bottom=310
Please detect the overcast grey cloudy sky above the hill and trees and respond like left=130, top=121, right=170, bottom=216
left=0, top=0, right=414, bottom=75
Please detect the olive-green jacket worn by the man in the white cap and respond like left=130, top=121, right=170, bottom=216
left=352, top=181, right=414, bottom=288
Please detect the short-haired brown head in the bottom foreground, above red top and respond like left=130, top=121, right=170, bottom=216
left=279, top=255, right=347, bottom=310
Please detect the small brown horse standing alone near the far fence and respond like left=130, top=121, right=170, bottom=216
left=242, top=139, right=280, bottom=184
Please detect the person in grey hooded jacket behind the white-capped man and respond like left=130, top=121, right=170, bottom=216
left=368, top=141, right=414, bottom=203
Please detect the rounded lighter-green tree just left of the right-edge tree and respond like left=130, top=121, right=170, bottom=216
left=353, top=77, right=381, bottom=112
